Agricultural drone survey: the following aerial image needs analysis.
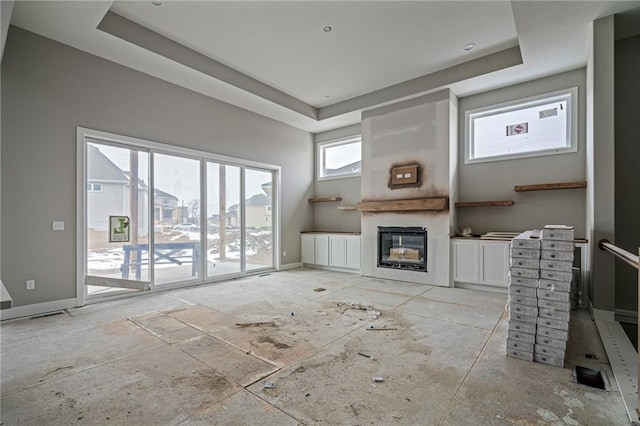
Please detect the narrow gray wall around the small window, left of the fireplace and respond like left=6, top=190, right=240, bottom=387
left=310, top=124, right=364, bottom=232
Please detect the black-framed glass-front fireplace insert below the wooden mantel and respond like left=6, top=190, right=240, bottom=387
left=378, top=226, right=427, bottom=272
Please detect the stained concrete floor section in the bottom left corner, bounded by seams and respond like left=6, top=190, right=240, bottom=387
left=2, top=345, right=239, bottom=425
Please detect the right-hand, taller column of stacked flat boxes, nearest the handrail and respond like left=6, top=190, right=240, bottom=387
left=534, top=225, right=575, bottom=367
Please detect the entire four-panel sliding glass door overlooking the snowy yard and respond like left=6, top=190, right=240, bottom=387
left=80, top=130, right=277, bottom=297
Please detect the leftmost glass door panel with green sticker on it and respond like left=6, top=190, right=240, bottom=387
left=84, top=141, right=150, bottom=295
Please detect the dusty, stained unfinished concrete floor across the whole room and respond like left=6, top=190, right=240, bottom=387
left=1, top=269, right=629, bottom=425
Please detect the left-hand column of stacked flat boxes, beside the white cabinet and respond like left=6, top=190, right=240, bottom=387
left=507, top=231, right=540, bottom=361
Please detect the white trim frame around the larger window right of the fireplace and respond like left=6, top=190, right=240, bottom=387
left=464, top=87, right=578, bottom=164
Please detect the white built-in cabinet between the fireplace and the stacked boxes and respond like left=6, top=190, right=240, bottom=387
left=451, top=240, right=510, bottom=287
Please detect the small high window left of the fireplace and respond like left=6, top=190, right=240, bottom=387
left=317, top=136, right=362, bottom=179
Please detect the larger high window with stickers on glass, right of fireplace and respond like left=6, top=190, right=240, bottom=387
left=465, top=88, right=578, bottom=164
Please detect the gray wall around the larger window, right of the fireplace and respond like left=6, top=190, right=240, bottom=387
left=456, top=69, right=586, bottom=237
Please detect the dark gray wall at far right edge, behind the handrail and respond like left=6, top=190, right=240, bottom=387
left=615, top=32, right=640, bottom=312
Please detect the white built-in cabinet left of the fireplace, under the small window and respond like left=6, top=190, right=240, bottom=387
left=301, top=233, right=360, bottom=270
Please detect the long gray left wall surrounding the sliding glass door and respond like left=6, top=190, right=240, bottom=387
left=1, top=27, right=313, bottom=306
